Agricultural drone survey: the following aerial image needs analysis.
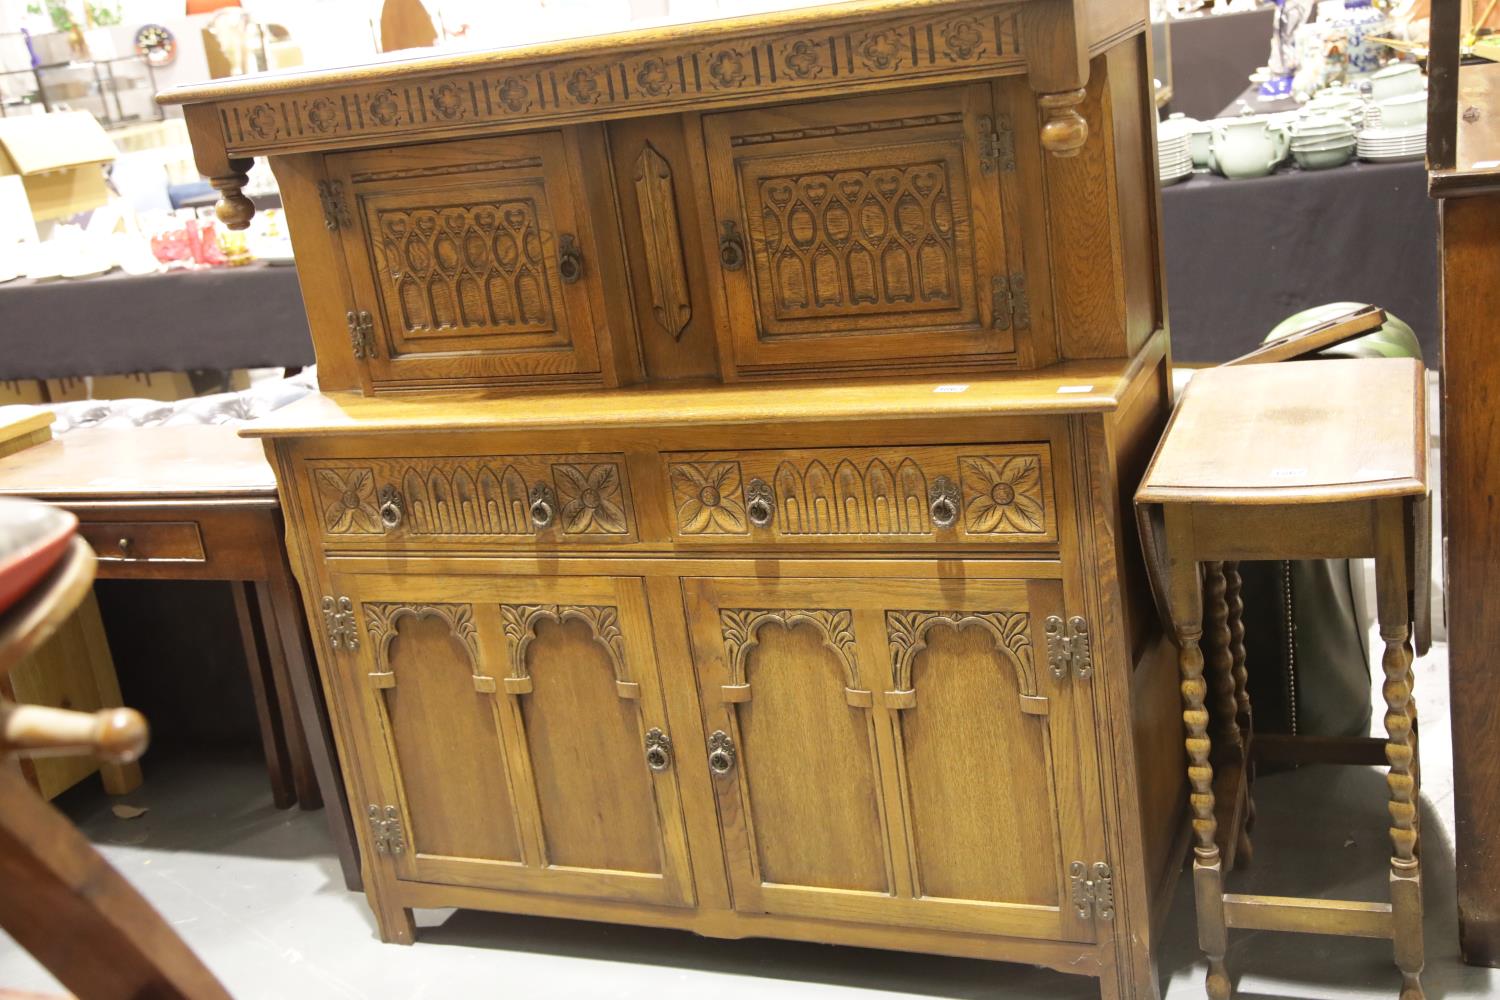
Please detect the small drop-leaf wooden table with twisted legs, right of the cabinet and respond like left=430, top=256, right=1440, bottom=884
left=1136, top=358, right=1428, bottom=1000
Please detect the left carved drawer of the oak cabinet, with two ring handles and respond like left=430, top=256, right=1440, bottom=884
left=305, top=454, right=638, bottom=546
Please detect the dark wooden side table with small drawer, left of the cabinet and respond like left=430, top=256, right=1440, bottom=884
left=0, top=424, right=362, bottom=889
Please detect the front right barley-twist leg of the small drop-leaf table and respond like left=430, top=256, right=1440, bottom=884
left=1376, top=499, right=1424, bottom=1000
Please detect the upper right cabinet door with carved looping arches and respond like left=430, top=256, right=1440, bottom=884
left=704, top=85, right=1029, bottom=369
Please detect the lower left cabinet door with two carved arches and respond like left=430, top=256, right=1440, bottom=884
left=335, top=574, right=690, bottom=904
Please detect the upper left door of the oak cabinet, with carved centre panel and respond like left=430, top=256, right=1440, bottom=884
left=327, top=132, right=600, bottom=387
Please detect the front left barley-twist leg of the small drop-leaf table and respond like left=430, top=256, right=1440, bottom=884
left=1166, top=507, right=1233, bottom=1000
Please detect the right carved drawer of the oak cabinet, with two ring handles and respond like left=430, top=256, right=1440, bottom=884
left=663, top=442, right=1058, bottom=547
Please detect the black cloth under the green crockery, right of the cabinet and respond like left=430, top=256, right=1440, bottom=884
left=1161, top=162, right=1440, bottom=367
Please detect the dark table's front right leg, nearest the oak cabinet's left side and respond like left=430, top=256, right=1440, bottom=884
left=266, top=567, right=365, bottom=892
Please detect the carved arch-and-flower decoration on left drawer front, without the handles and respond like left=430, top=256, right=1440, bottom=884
left=312, top=454, right=633, bottom=540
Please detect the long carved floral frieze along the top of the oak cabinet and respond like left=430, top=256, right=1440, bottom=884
left=219, top=4, right=1023, bottom=154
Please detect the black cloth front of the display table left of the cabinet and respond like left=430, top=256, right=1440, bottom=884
left=0, top=264, right=312, bottom=381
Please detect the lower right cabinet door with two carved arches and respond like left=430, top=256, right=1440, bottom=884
left=684, top=570, right=1101, bottom=940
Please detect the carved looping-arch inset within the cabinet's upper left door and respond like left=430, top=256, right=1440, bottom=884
left=372, top=198, right=555, bottom=334
